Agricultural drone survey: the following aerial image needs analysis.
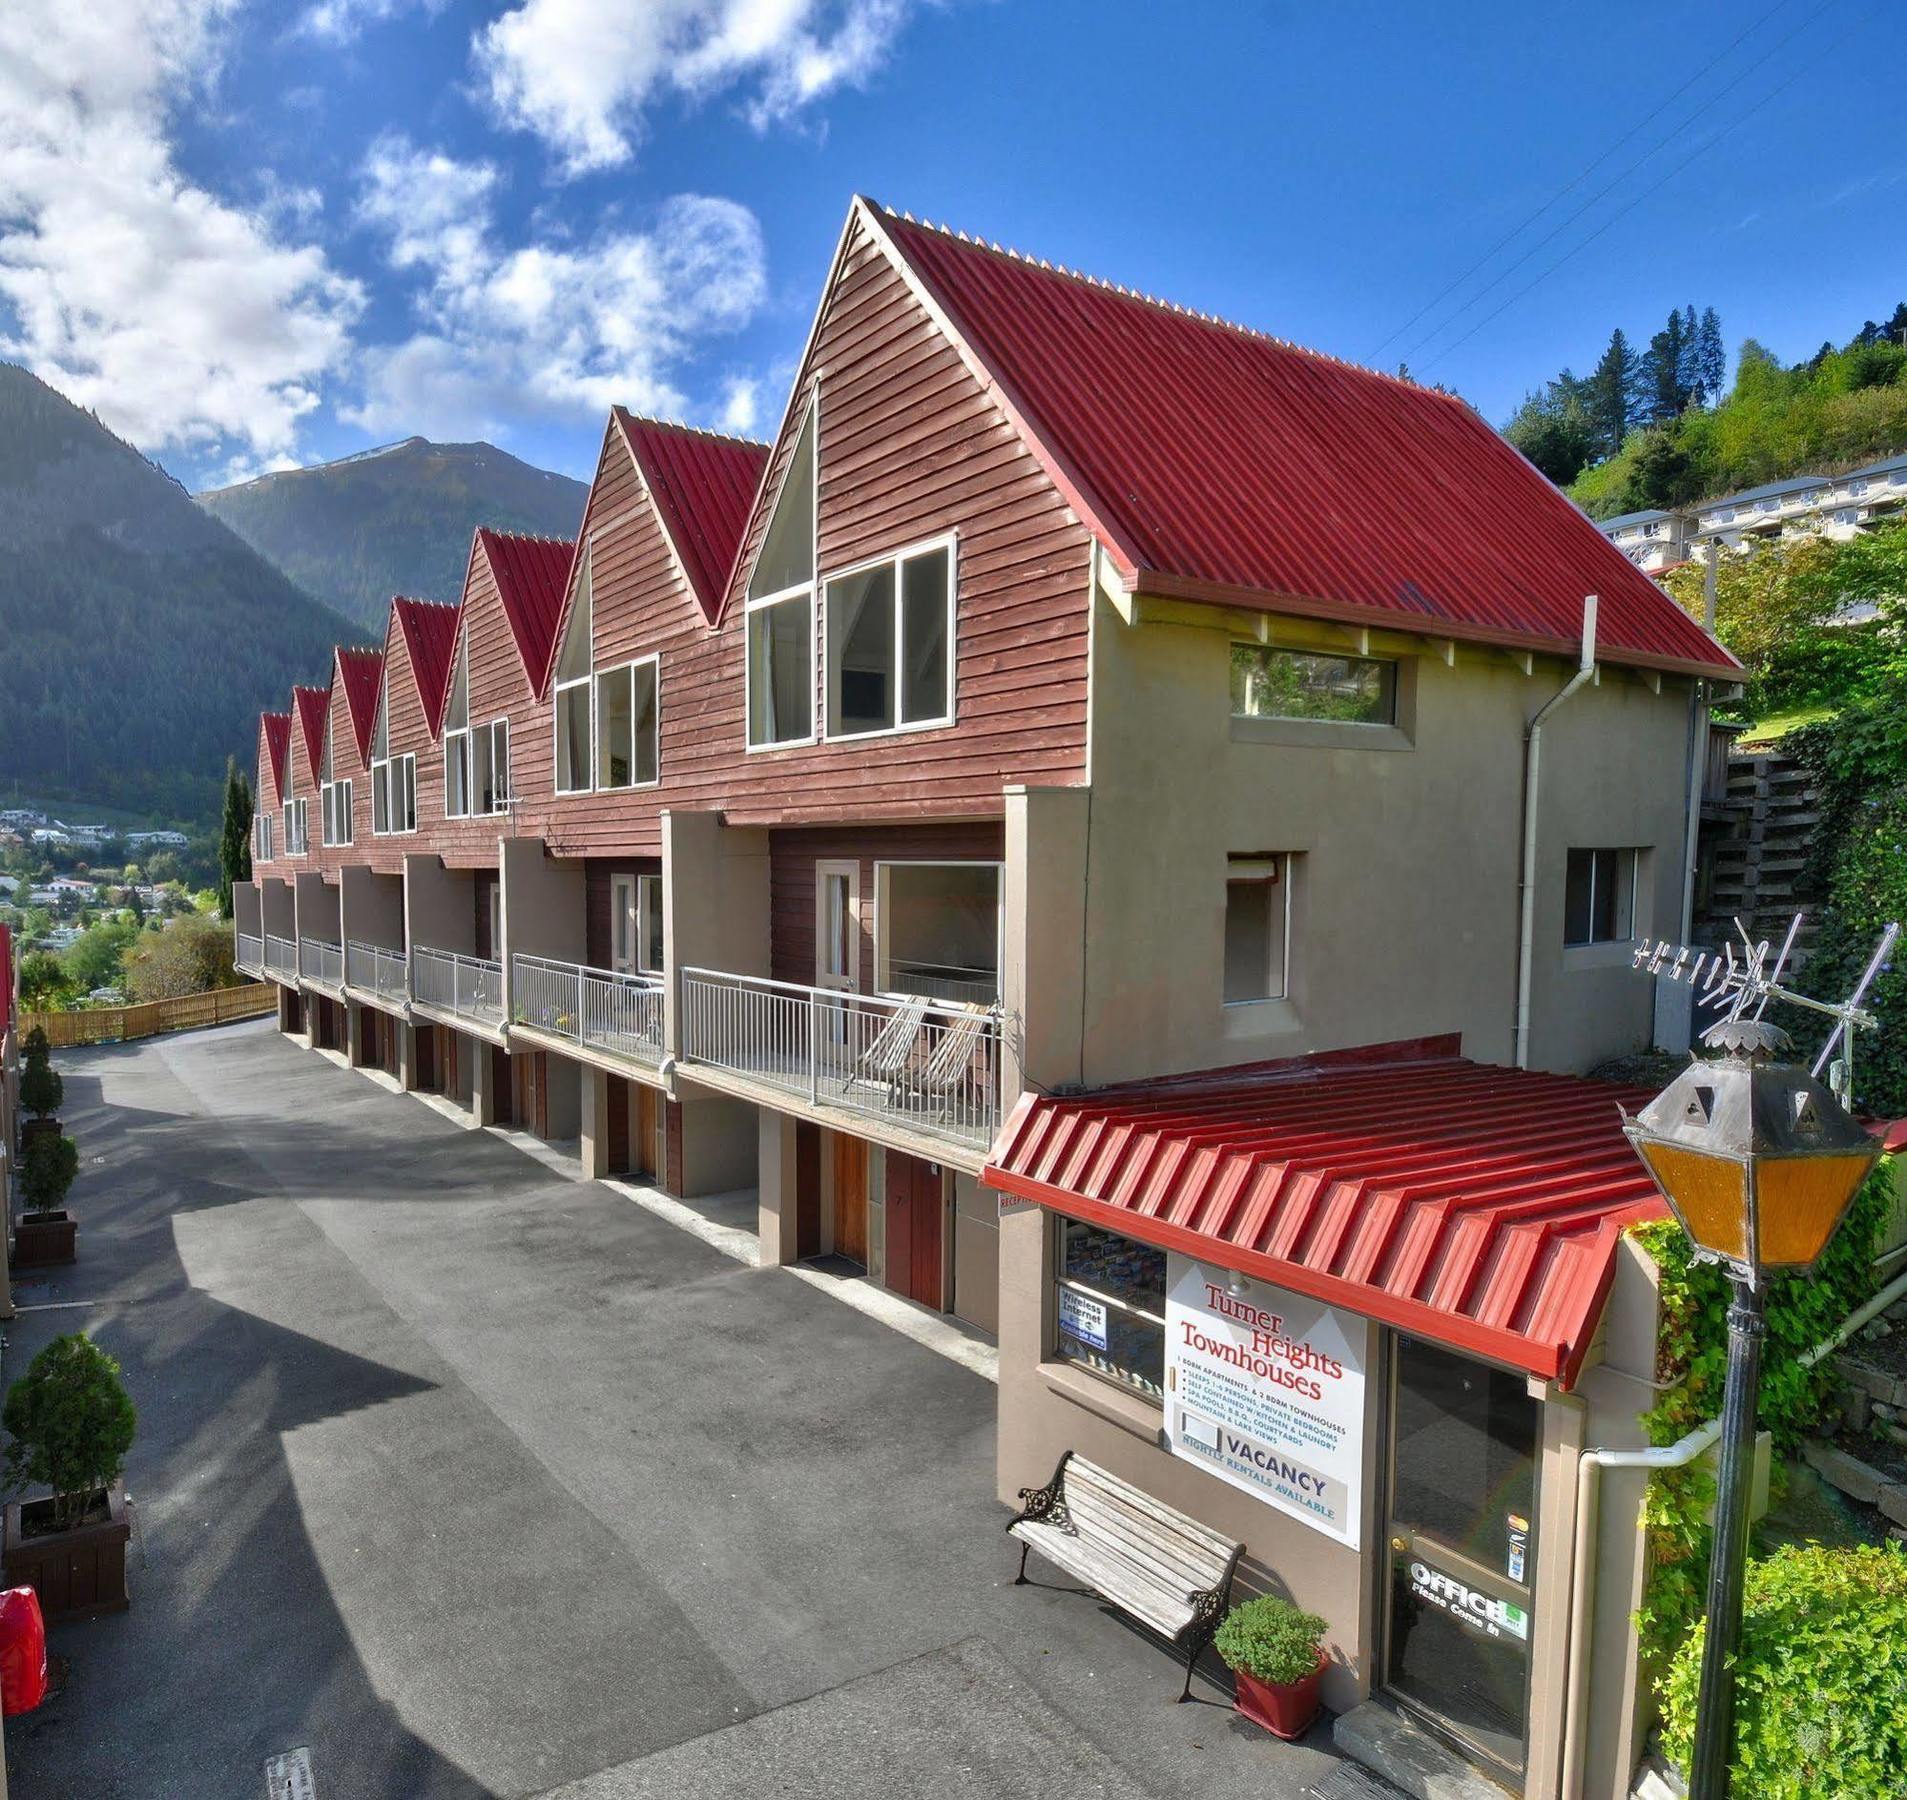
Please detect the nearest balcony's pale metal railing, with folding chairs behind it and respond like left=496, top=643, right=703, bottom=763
left=683, top=969, right=1001, bottom=1144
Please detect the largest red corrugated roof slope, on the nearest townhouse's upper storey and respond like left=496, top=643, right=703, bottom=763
left=864, top=202, right=1737, bottom=675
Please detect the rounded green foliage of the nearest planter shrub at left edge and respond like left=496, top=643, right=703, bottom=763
left=0, top=1333, right=137, bottom=1531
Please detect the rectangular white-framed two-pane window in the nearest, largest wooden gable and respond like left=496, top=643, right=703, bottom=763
left=822, top=542, right=954, bottom=738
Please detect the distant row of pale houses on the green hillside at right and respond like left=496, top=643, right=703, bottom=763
left=1602, top=452, right=1907, bottom=574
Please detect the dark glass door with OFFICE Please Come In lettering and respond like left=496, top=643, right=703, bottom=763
left=1384, top=1337, right=1539, bottom=1777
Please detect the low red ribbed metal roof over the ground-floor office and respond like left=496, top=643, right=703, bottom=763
left=984, top=1039, right=1667, bottom=1384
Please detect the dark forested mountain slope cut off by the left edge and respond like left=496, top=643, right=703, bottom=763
left=0, top=362, right=362, bottom=824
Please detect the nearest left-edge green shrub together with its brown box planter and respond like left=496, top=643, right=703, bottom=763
left=0, top=1333, right=137, bottom=1619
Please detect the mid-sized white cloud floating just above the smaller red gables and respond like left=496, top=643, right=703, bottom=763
left=343, top=137, right=767, bottom=437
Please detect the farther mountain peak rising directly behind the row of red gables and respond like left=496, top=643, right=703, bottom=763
left=198, top=437, right=589, bottom=635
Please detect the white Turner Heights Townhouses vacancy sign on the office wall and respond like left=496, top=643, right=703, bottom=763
left=1165, top=1255, right=1371, bottom=1550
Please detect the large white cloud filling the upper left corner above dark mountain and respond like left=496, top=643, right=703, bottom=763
left=0, top=0, right=362, bottom=470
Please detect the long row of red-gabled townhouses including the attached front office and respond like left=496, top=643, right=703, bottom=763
left=236, top=200, right=1737, bottom=1796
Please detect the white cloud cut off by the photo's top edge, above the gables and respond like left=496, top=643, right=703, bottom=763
left=473, top=0, right=919, bottom=174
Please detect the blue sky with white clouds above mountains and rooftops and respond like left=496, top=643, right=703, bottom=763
left=0, top=0, right=1907, bottom=486
